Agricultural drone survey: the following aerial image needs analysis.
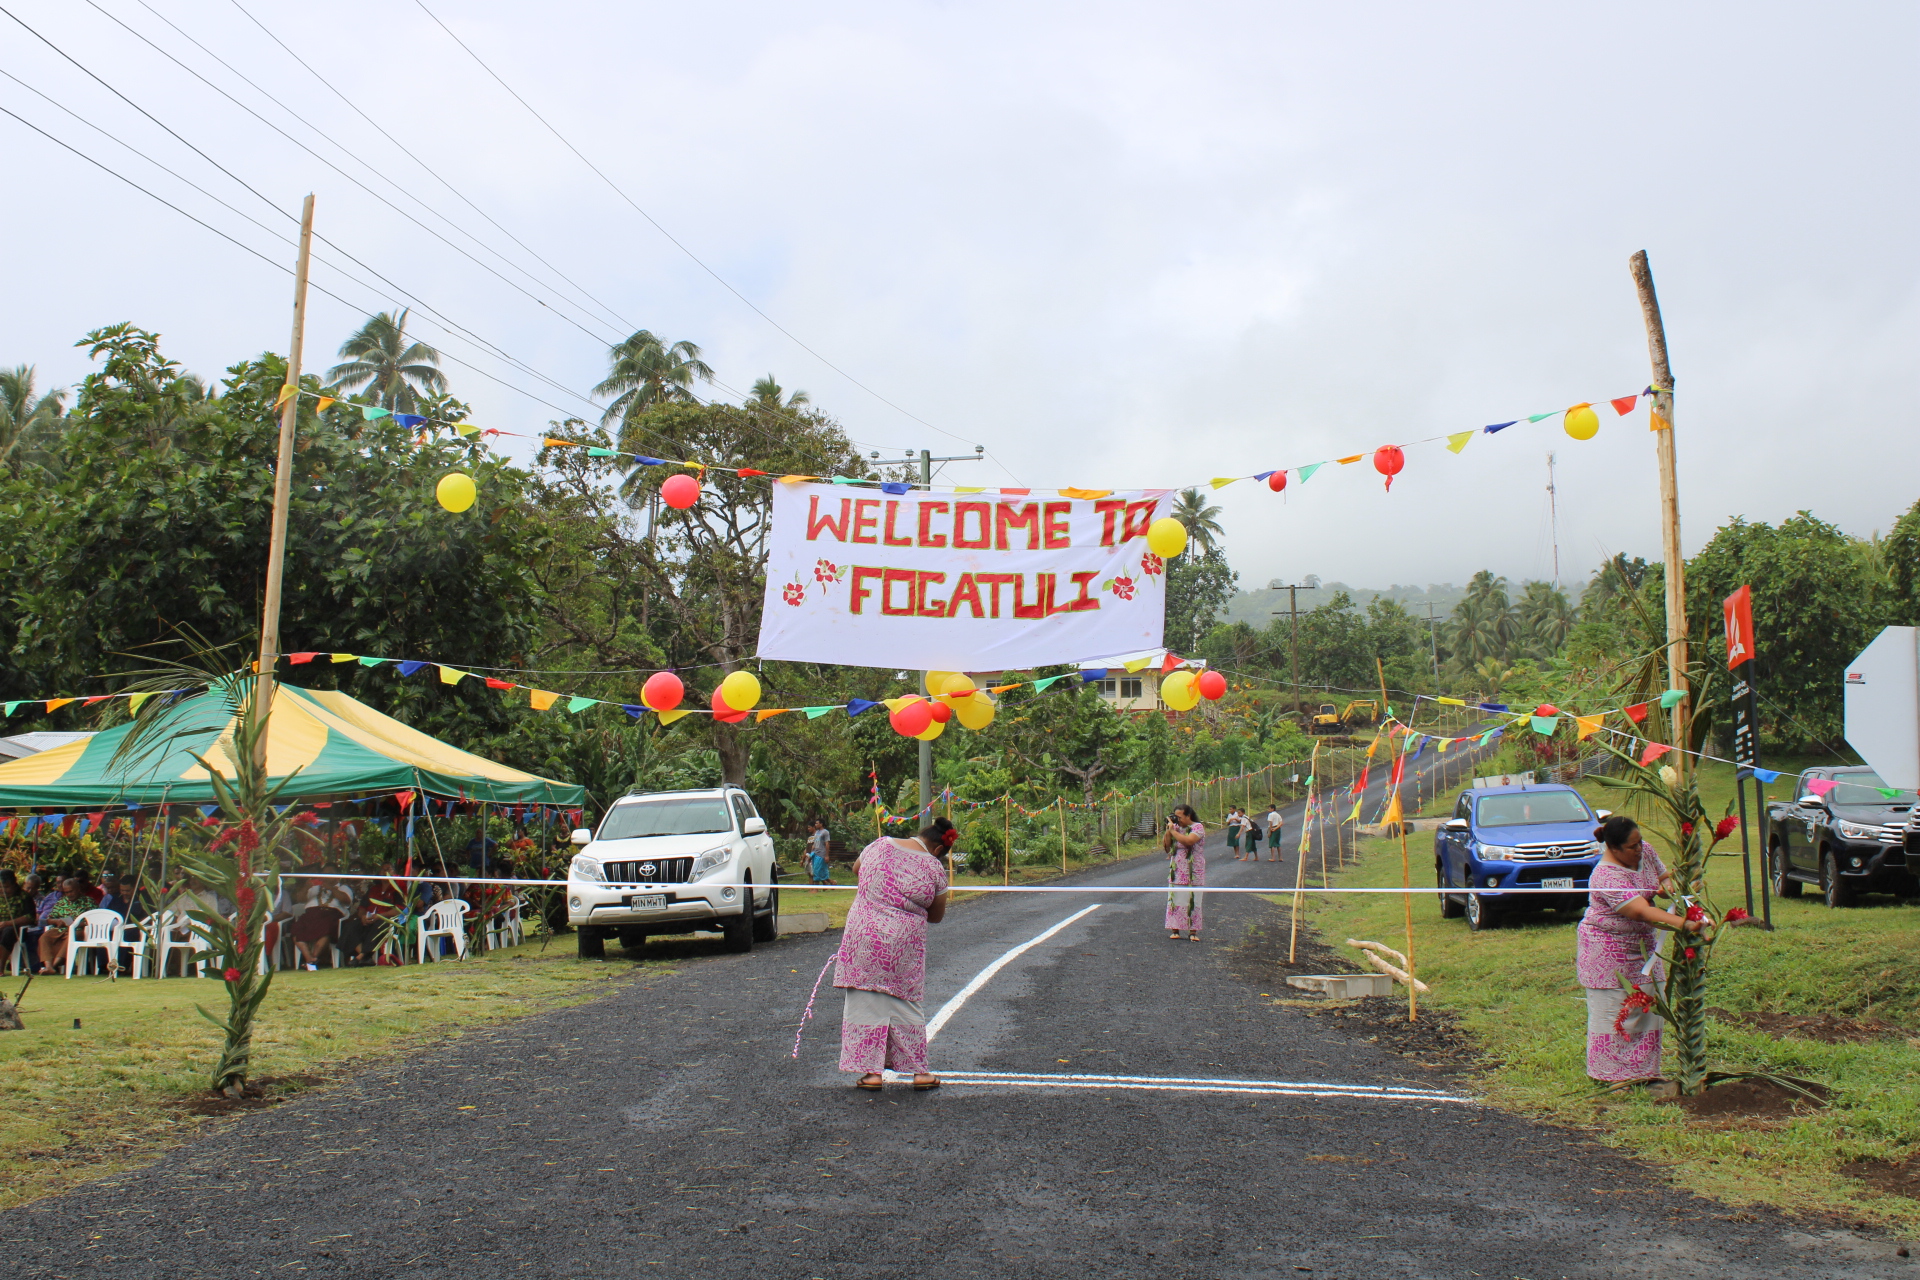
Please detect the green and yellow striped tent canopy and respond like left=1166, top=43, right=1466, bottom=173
left=0, top=685, right=586, bottom=808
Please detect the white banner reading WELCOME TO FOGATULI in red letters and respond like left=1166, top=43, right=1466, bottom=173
left=760, top=484, right=1167, bottom=672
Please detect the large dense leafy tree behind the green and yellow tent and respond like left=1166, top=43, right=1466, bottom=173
left=0, top=326, right=541, bottom=748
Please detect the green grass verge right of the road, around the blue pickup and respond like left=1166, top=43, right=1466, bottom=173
left=1311, top=768, right=1920, bottom=1230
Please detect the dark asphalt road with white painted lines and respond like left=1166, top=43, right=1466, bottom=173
left=6, top=752, right=1914, bottom=1280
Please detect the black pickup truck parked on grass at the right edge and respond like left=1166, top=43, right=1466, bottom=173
left=1766, top=766, right=1916, bottom=906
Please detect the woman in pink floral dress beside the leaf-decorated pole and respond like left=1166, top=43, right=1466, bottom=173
left=1574, top=814, right=1707, bottom=1084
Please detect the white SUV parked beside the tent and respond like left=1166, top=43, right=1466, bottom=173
left=566, top=787, right=780, bottom=958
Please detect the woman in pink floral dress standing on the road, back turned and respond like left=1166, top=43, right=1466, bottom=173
left=833, top=818, right=958, bottom=1090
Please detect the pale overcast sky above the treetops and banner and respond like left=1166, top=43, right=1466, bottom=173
left=0, top=0, right=1920, bottom=587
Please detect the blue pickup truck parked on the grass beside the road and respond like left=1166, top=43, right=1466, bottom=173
left=1434, top=783, right=1607, bottom=933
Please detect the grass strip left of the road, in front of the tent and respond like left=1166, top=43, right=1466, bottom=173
left=0, top=938, right=639, bottom=1209
